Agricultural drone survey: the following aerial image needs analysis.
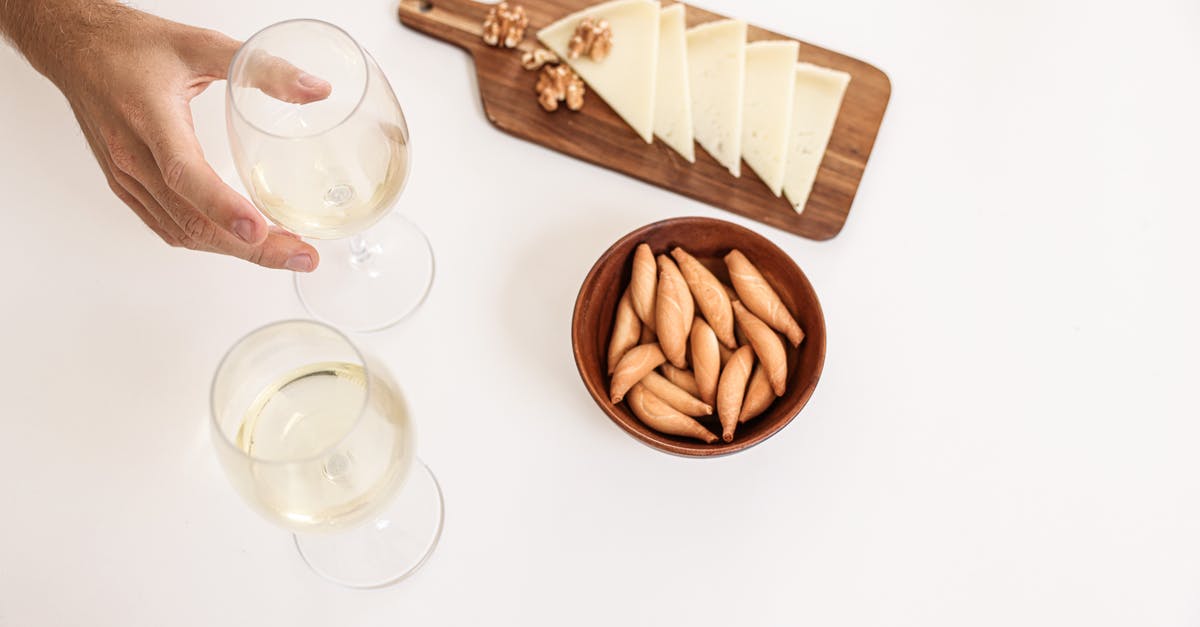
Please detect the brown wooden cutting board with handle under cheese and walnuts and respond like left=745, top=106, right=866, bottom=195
left=400, top=0, right=892, bottom=239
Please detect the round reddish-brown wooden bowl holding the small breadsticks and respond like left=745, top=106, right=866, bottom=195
left=571, top=217, right=826, bottom=456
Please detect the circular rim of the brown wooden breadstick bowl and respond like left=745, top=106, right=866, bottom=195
left=571, top=216, right=826, bottom=458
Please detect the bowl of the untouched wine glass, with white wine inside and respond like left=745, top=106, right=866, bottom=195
left=212, top=321, right=414, bottom=533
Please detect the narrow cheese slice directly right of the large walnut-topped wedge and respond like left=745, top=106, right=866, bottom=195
left=654, top=4, right=696, bottom=163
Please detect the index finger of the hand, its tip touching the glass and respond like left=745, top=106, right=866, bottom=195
left=136, top=101, right=268, bottom=244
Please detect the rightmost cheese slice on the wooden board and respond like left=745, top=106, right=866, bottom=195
left=784, top=62, right=850, bottom=213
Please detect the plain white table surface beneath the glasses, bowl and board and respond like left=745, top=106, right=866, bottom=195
left=0, top=0, right=1200, bottom=627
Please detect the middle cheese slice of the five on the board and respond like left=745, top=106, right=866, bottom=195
left=688, top=19, right=746, bottom=177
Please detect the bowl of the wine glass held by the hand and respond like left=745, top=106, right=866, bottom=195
left=226, top=19, right=409, bottom=239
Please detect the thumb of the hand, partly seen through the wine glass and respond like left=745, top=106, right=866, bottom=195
left=181, top=29, right=334, bottom=105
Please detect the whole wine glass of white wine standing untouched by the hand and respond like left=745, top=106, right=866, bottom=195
left=211, top=320, right=443, bottom=587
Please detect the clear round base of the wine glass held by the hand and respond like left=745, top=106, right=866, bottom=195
left=295, top=214, right=433, bottom=332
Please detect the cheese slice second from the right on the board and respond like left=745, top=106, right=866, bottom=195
left=742, top=41, right=800, bottom=196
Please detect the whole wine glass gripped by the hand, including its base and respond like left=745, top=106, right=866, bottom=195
left=226, top=19, right=433, bottom=332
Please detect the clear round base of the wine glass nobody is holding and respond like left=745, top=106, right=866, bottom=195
left=293, top=460, right=444, bottom=589
